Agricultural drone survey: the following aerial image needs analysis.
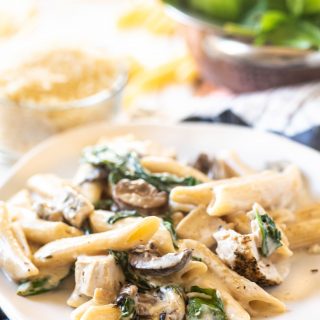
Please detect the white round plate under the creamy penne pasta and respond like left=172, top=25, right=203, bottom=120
left=0, top=124, right=320, bottom=320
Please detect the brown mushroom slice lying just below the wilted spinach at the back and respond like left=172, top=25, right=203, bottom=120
left=113, top=179, right=168, bottom=209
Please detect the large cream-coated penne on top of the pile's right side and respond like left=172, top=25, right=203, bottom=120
left=207, top=166, right=306, bottom=216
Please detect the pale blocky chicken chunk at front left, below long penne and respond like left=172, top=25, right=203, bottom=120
left=67, top=255, right=124, bottom=307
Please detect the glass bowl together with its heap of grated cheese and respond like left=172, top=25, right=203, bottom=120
left=0, top=48, right=126, bottom=155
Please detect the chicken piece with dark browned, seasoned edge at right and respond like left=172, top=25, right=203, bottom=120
left=214, top=229, right=283, bottom=286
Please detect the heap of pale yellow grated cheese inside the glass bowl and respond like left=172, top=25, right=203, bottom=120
left=0, top=48, right=116, bottom=107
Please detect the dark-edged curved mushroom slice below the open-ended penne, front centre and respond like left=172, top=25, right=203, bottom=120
left=129, top=249, right=192, bottom=277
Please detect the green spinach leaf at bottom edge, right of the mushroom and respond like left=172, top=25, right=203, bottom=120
left=186, top=286, right=227, bottom=320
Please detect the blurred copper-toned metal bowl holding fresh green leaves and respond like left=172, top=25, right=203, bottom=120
left=166, top=4, right=320, bottom=92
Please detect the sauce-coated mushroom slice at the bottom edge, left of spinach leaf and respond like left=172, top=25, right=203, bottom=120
left=136, top=286, right=185, bottom=320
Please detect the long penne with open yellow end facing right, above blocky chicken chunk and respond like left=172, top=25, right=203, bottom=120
left=34, top=217, right=161, bottom=265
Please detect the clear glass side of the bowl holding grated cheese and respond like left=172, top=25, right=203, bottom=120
left=0, top=64, right=127, bottom=162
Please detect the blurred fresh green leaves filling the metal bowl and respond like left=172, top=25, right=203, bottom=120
left=165, top=0, right=320, bottom=49
